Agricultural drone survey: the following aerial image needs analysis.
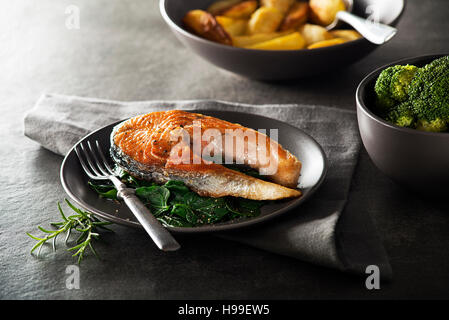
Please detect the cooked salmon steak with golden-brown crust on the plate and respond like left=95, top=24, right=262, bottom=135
left=110, top=110, right=301, bottom=200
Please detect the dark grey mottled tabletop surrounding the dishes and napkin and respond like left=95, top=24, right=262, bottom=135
left=0, top=0, right=449, bottom=299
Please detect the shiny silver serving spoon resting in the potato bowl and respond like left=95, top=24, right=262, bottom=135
left=326, top=0, right=398, bottom=44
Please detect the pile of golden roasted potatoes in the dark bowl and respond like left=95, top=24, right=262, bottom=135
left=187, top=0, right=362, bottom=50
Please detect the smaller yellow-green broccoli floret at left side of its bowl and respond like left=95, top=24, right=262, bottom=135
left=374, top=65, right=418, bottom=113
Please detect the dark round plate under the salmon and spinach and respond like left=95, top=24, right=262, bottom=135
left=61, top=110, right=327, bottom=233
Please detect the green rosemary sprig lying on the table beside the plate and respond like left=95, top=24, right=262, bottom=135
left=26, top=199, right=112, bottom=264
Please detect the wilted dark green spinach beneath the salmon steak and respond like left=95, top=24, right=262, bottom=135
left=89, top=171, right=266, bottom=227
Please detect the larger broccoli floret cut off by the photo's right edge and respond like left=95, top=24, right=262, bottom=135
left=409, top=56, right=449, bottom=123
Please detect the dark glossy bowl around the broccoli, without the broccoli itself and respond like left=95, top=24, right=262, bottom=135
left=356, top=54, right=449, bottom=196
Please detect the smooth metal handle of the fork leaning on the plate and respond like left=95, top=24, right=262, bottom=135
left=117, top=188, right=181, bottom=251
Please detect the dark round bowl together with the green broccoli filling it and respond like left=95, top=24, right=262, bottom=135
left=356, top=53, right=449, bottom=197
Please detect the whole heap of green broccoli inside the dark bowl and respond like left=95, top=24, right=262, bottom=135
left=374, top=56, right=449, bottom=132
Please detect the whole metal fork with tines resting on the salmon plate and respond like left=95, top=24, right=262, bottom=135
left=75, top=140, right=181, bottom=251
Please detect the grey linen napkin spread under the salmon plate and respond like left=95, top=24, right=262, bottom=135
left=25, top=94, right=392, bottom=280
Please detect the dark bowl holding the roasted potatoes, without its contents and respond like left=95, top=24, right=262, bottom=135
left=160, top=0, right=405, bottom=80
